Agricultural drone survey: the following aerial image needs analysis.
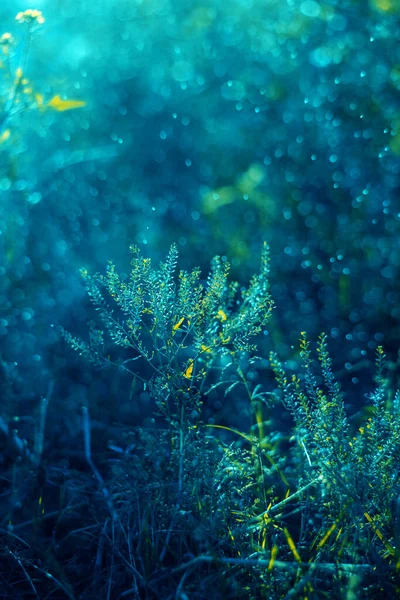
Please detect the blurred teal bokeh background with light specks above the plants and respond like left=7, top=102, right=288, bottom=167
left=0, top=0, right=400, bottom=431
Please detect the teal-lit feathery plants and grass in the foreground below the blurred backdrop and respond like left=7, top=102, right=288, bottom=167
left=1, top=245, right=400, bottom=598
